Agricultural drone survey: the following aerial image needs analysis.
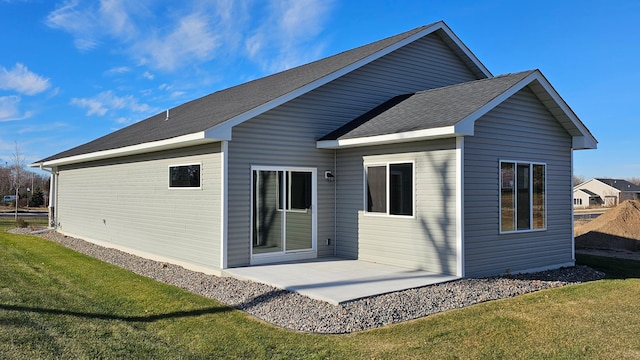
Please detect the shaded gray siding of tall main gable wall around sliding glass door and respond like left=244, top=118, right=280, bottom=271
left=227, top=34, right=476, bottom=267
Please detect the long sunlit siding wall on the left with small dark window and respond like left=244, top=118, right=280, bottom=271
left=56, top=143, right=222, bottom=270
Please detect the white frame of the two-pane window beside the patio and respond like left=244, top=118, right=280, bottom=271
left=363, top=160, right=416, bottom=218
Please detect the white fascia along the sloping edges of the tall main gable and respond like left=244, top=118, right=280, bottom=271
left=205, top=21, right=492, bottom=141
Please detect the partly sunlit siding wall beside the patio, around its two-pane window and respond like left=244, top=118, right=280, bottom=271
left=336, top=139, right=457, bottom=274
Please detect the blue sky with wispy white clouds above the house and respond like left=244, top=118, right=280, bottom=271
left=0, top=0, right=640, bottom=178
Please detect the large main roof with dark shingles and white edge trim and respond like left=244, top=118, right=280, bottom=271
left=31, top=21, right=491, bottom=166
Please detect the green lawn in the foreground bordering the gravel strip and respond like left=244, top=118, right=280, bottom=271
left=0, top=220, right=640, bottom=359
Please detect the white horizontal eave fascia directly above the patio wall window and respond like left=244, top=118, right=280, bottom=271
left=316, top=126, right=460, bottom=149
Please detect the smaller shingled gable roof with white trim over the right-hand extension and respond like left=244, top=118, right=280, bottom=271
left=317, top=70, right=597, bottom=149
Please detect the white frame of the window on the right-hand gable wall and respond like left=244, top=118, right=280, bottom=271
left=498, top=159, right=548, bottom=234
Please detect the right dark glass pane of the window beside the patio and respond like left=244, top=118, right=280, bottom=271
left=389, top=163, right=413, bottom=216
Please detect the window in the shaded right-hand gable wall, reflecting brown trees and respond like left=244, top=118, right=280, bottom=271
left=500, top=161, right=547, bottom=232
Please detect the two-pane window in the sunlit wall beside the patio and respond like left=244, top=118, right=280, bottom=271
left=366, top=163, right=413, bottom=216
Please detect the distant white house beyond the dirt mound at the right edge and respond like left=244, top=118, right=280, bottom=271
left=573, top=178, right=640, bottom=208
